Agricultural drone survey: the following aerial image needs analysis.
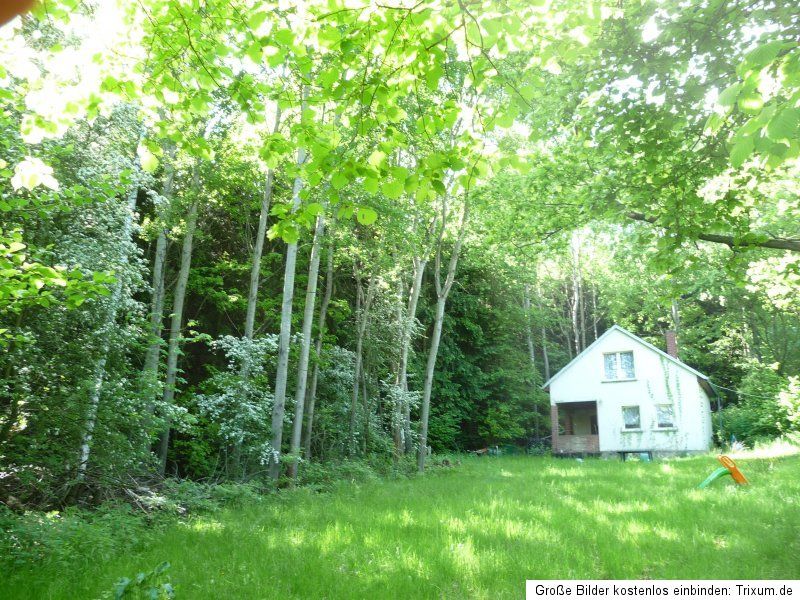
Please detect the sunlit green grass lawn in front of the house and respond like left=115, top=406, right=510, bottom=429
left=0, top=456, right=800, bottom=599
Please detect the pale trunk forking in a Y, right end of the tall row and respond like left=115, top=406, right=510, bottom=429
left=417, top=194, right=469, bottom=473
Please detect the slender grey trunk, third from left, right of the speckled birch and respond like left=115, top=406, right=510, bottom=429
left=158, top=162, right=200, bottom=475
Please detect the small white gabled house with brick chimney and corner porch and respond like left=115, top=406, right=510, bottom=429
left=542, top=325, right=714, bottom=454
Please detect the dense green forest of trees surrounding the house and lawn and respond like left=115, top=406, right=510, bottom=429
left=0, top=0, right=800, bottom=508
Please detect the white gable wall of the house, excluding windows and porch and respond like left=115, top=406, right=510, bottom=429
left=550, top=329, right=711, bottom=452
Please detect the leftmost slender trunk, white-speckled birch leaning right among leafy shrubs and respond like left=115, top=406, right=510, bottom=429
left=76, top=175, right=139, bottom=483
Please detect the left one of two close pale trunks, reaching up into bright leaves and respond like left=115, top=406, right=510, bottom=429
left=269, top=134, right=306, bottom=480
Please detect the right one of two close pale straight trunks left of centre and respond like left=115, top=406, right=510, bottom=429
left=289, top=214, right=325, bottom=479
